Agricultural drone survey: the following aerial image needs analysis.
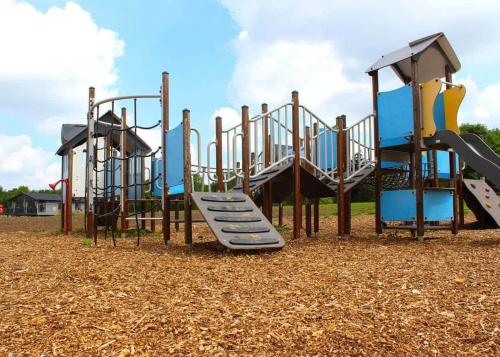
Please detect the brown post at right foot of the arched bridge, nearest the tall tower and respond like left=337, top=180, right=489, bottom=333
left=337, top=115, right=345, bottom=237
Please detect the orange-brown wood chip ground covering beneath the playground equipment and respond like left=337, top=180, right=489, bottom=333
left=0, top=215, right=500, bottom=356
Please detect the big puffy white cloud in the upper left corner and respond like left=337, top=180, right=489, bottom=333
left=0, top=0, right=124, bottom=133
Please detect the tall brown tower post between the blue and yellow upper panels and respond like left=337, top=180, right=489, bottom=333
left=411, top=58, right=424, bottom=240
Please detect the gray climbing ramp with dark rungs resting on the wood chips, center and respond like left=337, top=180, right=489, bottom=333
left=191, top=192, right=285, bottom=250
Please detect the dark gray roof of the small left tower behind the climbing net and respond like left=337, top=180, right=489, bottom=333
left=56, top=111, right=151, bottom=156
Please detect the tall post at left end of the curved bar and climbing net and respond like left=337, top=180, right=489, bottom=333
left=85, top=87, right=95, bottom=238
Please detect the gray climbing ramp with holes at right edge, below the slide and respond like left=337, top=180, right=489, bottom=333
left=464, top=179, right=500, bottom=227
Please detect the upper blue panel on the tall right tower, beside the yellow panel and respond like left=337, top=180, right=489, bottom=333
left=377, top=85, right=413, bottom=147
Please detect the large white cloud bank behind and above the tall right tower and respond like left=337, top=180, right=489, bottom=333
left=219, top=0, right=500, bottom=125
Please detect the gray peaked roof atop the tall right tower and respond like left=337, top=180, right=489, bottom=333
left=366, top=32, right=461, bottom=83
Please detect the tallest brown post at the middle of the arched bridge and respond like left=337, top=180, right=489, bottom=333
left=292, top=91, right=302, bottom=239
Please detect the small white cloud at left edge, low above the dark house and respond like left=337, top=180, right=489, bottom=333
left=0, top=134, right=61, bottom=189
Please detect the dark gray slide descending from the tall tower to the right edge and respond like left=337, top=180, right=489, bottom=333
left=425, top=130, right=500, bottom=189
